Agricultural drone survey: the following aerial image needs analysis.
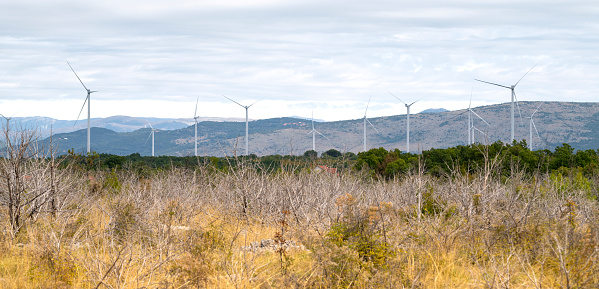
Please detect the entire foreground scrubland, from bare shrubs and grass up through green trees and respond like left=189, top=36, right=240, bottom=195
left=0, top=133, right=599, bottom=288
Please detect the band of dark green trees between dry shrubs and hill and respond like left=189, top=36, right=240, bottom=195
left=56, top=140, right=599, bottom=178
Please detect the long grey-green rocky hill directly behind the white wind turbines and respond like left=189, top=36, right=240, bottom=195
left=44, top=102, right=599, bottom=156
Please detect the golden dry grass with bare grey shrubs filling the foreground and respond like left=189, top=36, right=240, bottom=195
left=0, top=165, right=599, bottom=288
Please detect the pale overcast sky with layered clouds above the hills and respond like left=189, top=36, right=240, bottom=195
left=0, top=0, right=599, bottom=120
